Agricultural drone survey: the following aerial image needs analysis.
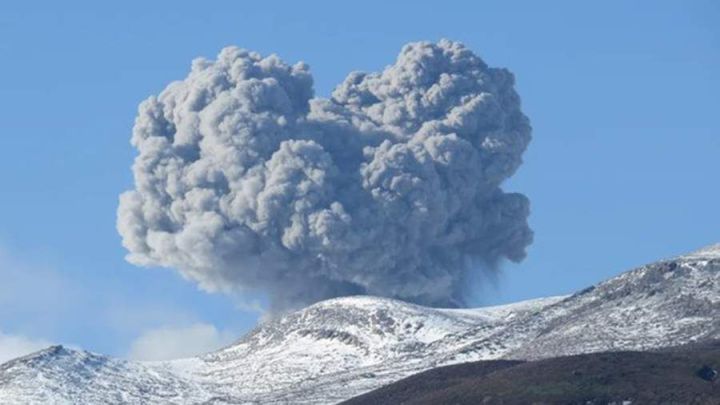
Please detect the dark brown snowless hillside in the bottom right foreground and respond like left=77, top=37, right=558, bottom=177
left=343, top=341, right=720, bottom=405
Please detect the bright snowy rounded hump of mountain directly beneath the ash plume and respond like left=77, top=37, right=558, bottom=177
left=180, top=297, right=560, bottom=403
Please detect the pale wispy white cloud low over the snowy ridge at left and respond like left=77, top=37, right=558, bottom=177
left=0, top=243, right=250, bottom=360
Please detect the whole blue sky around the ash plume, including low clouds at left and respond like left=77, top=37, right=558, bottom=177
left=0, top=0, right=720, bottom=360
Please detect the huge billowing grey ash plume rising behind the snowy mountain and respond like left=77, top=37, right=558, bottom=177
left=118, top=40, right=532, bottom=311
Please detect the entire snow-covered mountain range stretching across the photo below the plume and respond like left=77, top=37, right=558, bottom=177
left=0, top=241, right=720, bottom=404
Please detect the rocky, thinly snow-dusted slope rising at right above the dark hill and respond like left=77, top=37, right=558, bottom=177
left=452, top=245, right=720, bottom=361
